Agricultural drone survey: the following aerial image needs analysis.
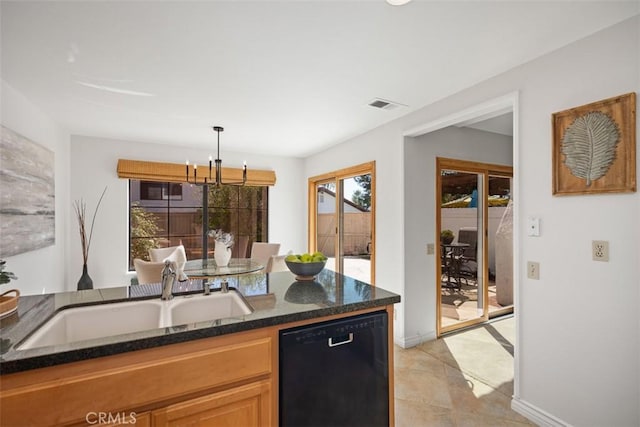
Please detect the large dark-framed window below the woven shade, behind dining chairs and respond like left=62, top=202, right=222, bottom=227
left=129, top=179, right=269, bottom=270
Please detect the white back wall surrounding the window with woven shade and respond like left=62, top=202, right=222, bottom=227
left=68, top=136, right=307, bottom=290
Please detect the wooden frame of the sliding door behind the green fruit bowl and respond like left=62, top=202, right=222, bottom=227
left=307, top=161, right=376, bottom=285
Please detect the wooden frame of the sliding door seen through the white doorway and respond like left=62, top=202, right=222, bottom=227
left=435, top=157, right=515, bottom=337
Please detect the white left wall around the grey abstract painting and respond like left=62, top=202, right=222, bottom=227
left=0, top=80, right=70, bottom=295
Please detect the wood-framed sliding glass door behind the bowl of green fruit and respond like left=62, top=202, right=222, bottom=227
left=309, top=163, right=375, bottom=283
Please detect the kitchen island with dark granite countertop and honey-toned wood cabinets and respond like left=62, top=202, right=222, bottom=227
left=0, top=270, right=400, bottom=425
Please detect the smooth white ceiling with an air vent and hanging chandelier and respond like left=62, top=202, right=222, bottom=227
left=0, top=0, right=640, bottom=157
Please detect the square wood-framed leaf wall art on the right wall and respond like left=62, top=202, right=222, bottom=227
left=552, top=93, right=636, bottom=195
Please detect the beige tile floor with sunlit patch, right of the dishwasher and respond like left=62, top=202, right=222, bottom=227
left=394, top=316, right=534, bottom=427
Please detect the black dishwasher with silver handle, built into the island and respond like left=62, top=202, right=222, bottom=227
left=280, top=311, right=389, bottom=427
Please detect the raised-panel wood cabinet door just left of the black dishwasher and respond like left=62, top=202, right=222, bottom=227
left=151, top=380, right=271, bottom=427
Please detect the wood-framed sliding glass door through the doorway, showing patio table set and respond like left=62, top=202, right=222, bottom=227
left=436, top=159, right=513, bottom=334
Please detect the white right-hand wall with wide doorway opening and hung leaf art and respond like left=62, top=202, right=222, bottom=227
left=305, top=16, right=640, bottom=426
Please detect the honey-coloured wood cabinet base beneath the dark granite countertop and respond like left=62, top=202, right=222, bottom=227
left=0, top=306, right=393, bottom=427
